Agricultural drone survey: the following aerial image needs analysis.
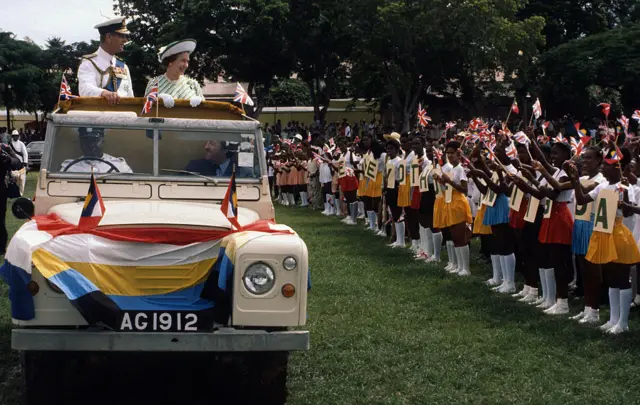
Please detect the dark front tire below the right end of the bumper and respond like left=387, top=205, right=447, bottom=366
left=242, top=352, right=289, bottom=405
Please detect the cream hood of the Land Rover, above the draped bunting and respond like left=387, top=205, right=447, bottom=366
left=49, top=200, right=260, bottom=229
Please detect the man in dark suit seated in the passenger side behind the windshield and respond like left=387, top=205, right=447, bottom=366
left=185, top=140, right=253, bottom=177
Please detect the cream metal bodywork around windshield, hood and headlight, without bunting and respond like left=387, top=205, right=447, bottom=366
left=14, top=110, right=308, bottom=344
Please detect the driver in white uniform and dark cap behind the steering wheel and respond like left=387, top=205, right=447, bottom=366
left=60, top=127, right=133, bottom=173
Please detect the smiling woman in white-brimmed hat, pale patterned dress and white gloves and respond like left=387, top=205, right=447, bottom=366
left=145, top=39, right=204, bottom=108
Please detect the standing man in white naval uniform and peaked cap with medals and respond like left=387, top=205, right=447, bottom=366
left=78, top=17, right=134, bottom=105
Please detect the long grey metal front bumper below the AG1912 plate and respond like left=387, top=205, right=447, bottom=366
left=11, top=328, right=309, bottom=352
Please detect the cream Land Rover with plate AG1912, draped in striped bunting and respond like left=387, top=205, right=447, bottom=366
left=7, top=98, right=309, bottom=404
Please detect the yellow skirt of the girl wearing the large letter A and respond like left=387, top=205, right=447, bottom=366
left=586, top=217, right=640, bottom=264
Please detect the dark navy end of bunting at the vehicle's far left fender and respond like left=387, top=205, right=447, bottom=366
left=0, top=259, right=36, bottom=321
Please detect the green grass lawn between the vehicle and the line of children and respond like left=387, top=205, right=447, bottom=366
left=0, top=178, right=640, bottom=405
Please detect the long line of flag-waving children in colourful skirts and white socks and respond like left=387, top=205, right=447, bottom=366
left=267, top=119, right=640, bottom=334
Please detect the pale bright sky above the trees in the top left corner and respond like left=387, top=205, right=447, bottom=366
left=0, top=0, right=114, bottom=46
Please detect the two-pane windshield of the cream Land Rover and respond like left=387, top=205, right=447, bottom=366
left=48, top=126, right=260, bottom=178
